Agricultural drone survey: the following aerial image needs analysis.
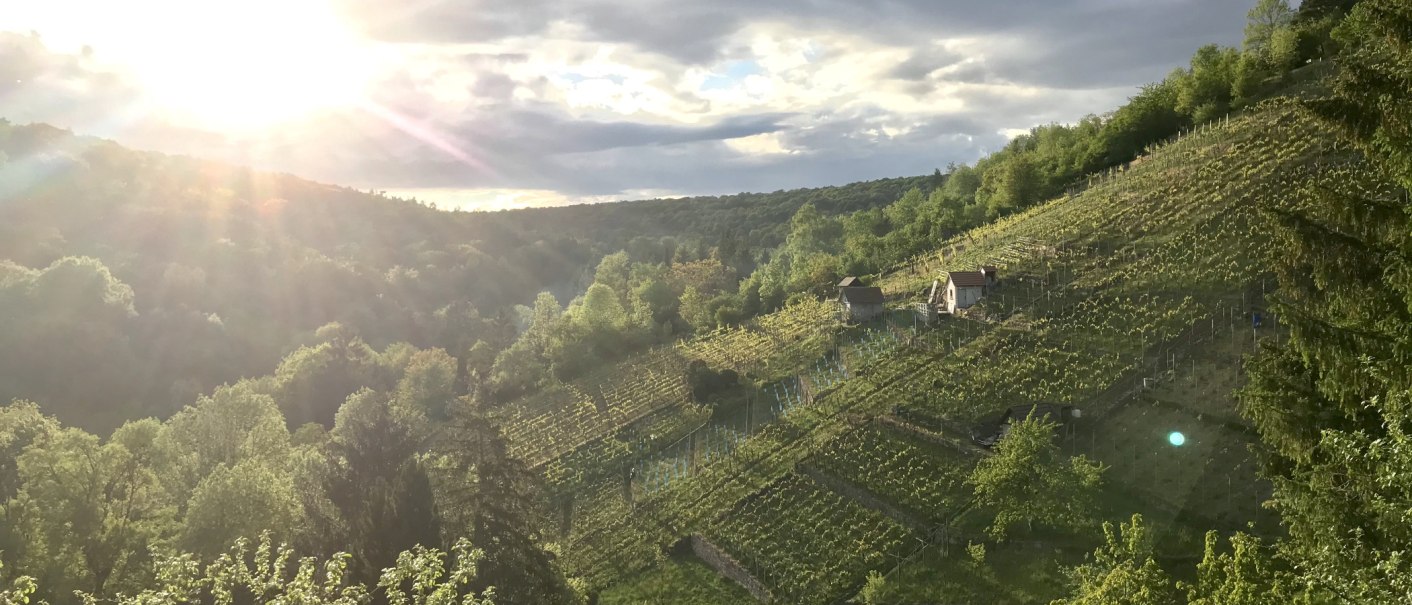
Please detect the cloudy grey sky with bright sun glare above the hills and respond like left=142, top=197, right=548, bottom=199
left=0, top=0, right=1254, bottom=209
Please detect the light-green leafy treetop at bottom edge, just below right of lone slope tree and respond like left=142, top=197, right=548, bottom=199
left=1053, top=515, right=1179, bottom=605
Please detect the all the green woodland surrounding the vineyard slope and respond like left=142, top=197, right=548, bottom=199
left=0, top=0, right=1412, bottom=605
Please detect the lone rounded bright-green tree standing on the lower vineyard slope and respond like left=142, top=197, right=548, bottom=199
left=967, top=418, right=1103, bottom=540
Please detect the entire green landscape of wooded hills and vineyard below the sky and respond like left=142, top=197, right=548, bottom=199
left=0, top=0, right=1412, bottom=605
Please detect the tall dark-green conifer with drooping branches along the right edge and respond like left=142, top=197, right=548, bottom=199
left=1241, top=0, right=1412, bottom=602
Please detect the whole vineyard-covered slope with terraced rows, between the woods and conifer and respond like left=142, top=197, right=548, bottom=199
left=485, top=96, right=1339, bottom=602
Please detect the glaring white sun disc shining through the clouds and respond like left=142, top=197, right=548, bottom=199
left=122, top=0, right=376, bottom=129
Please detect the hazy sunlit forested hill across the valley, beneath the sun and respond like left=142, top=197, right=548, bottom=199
left=0, top=122, right=926, bottom=433
